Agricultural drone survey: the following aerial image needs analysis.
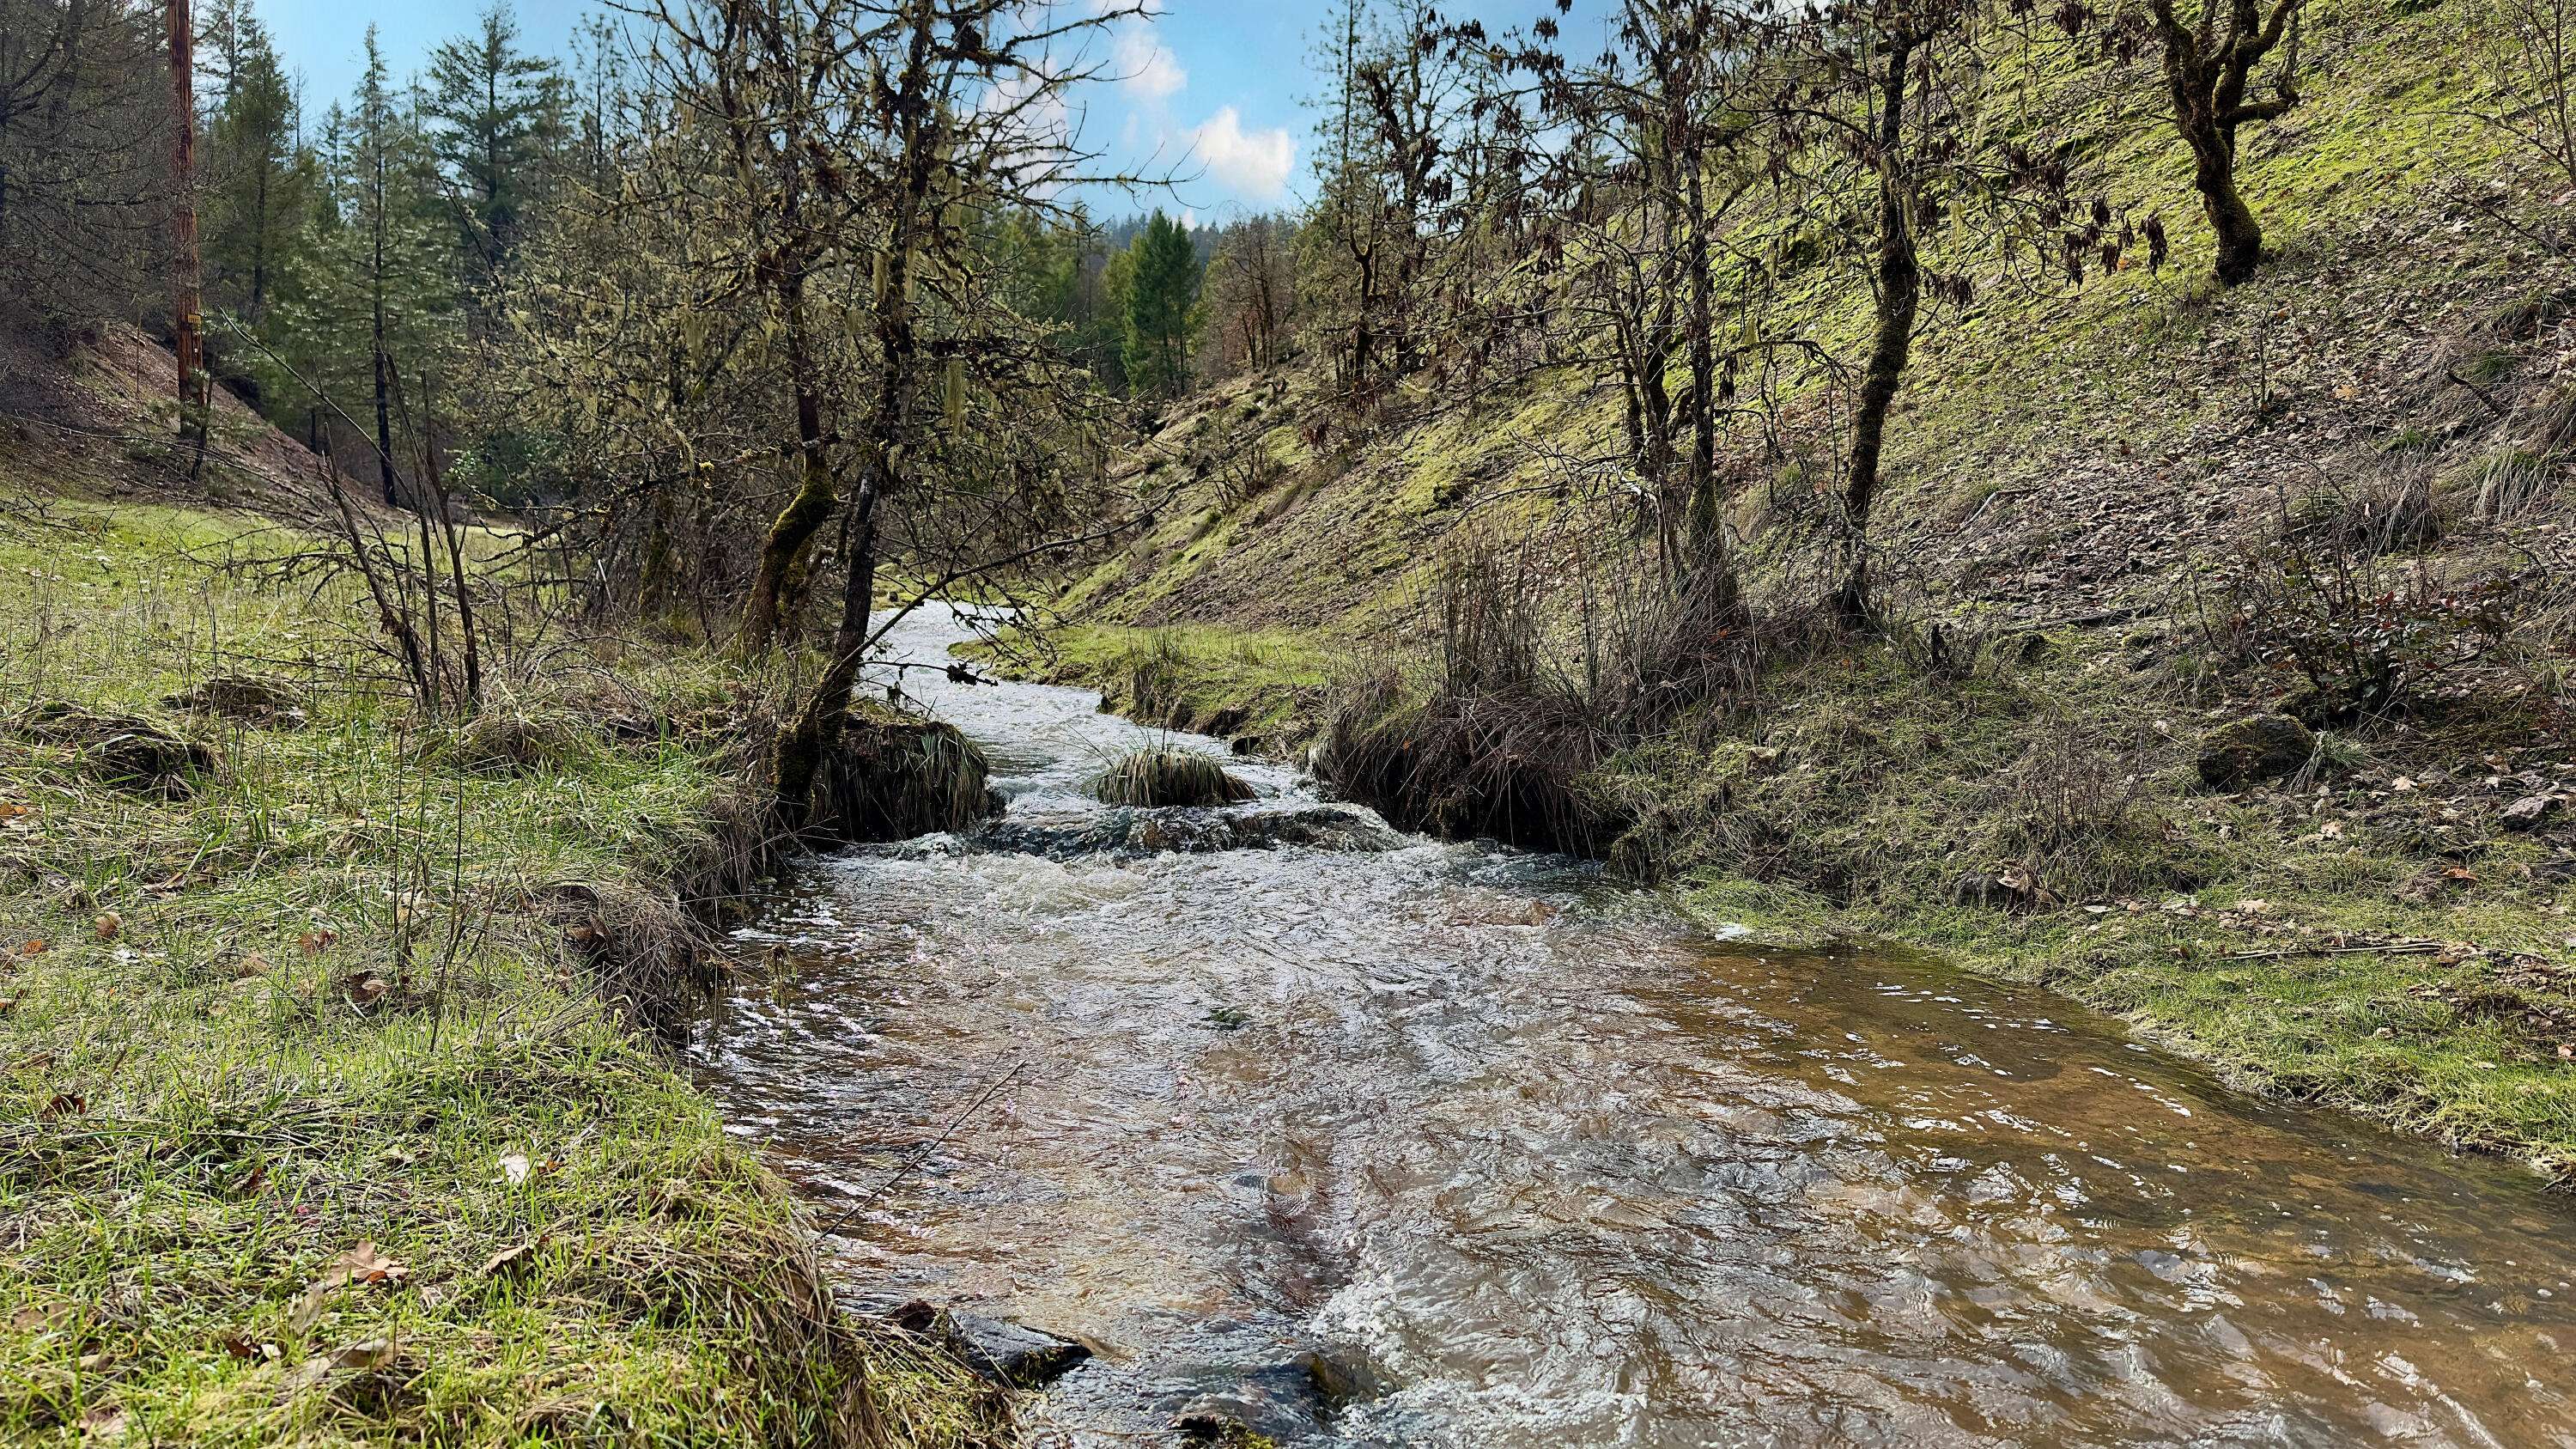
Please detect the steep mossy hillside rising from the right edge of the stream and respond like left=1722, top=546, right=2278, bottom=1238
left=1010, top=3, right=2576, bottom=1176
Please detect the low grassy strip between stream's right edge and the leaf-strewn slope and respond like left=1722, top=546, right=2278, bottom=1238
left=994, top=613, right=2576, bottom=1181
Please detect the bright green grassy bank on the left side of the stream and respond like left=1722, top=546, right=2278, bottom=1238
left=0, top=502, right=999, bottom=1444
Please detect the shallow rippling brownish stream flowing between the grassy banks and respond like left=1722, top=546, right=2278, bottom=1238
left=696, top=603, right=2576, bottom=1449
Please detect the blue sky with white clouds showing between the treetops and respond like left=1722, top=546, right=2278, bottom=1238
left=255, top=0, right=1553, bottom=219
